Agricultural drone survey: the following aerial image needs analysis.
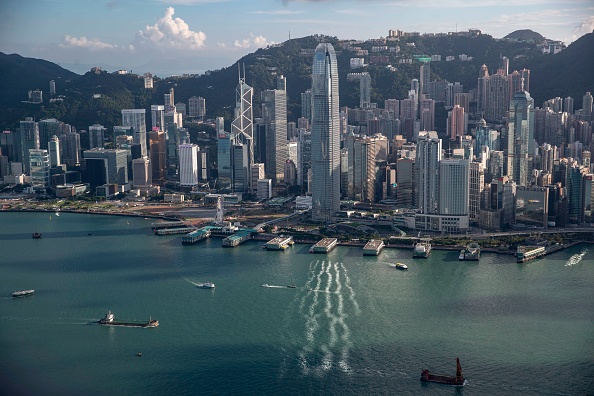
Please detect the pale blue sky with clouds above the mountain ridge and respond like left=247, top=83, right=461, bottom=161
left=0, top=0, right=594, bottom=77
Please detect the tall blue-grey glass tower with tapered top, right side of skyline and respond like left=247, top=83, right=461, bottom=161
left=507, top=91, right=534, bottom=186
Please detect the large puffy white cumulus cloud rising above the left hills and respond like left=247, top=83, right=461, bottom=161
left=134, top=7, right=206, bottom=50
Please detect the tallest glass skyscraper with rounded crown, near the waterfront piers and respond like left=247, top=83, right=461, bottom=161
left=311, top=43, right=340, bottom=223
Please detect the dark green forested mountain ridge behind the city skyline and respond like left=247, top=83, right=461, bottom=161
left=0, top=33, right=594, bottom=130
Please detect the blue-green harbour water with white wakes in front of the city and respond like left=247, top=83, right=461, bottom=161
left=0, top=212, right=594, bottom=395
